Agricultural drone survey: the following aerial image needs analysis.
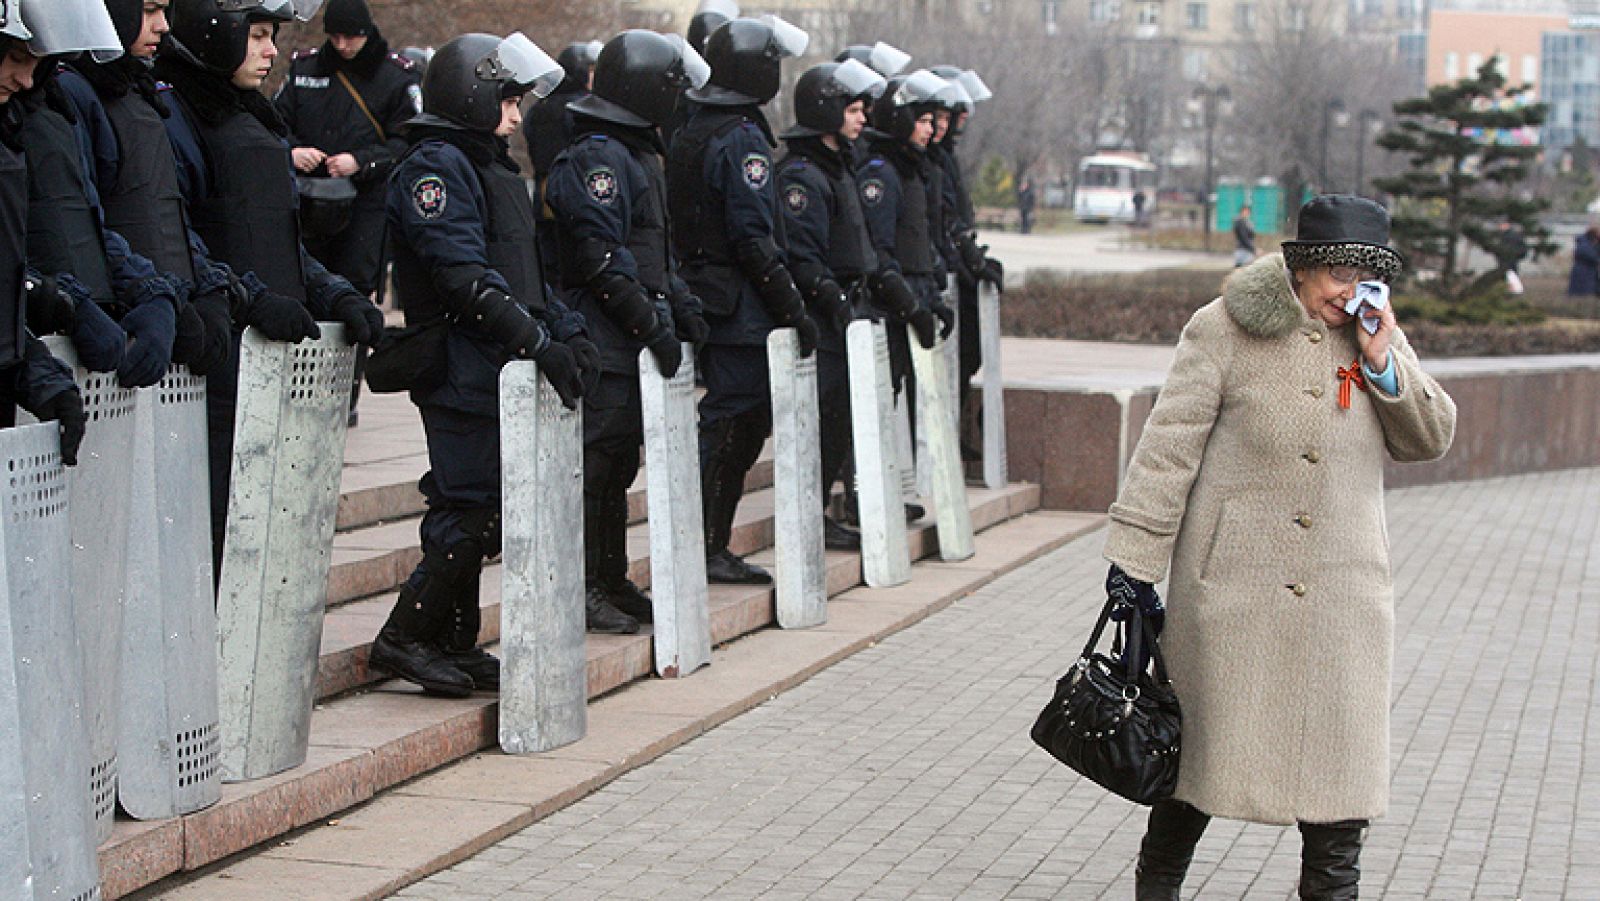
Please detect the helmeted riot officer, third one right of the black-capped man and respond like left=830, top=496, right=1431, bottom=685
left=667, top=16, right=818, bottom=584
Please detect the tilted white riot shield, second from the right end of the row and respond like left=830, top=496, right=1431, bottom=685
left=910, top=329, right=974, bottom=560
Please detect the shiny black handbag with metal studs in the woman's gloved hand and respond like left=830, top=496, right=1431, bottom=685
left=1032, top=599, right=1182, bottom=805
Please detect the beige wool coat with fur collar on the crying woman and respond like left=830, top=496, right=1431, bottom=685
left=1106, top=254, right=1456, bottom=824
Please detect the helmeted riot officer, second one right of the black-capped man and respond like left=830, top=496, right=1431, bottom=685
left=546, top=30, right=710, bottom=632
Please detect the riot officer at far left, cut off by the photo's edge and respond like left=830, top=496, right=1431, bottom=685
left=0, top=2, right=85, bottom=466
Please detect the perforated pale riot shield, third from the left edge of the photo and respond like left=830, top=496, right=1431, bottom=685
left=117, top=366, right=222, bottom=819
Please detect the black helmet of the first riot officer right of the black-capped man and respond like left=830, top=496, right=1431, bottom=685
left=422, top=32, right=563, bottom=133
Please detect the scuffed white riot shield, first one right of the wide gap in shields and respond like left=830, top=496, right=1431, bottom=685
left=499, top=360, right=589, bottom=754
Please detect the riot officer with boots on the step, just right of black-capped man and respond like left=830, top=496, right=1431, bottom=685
left=371, top=32, right=598, bottom=696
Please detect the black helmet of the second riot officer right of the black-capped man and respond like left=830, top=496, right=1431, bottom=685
left=566, top=29, right=710, bottom=128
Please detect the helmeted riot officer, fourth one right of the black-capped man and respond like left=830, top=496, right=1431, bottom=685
left=778, top=59, right=883, bottom=551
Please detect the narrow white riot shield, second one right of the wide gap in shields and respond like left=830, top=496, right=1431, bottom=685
left=638, top=344, right=710, bottom=679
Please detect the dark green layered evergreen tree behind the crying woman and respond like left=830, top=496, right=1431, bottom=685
left=1373, top=59, right=1555, bottom=301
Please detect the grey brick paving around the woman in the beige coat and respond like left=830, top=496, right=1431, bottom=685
left=390, top=469, right=1600, bottom=901
